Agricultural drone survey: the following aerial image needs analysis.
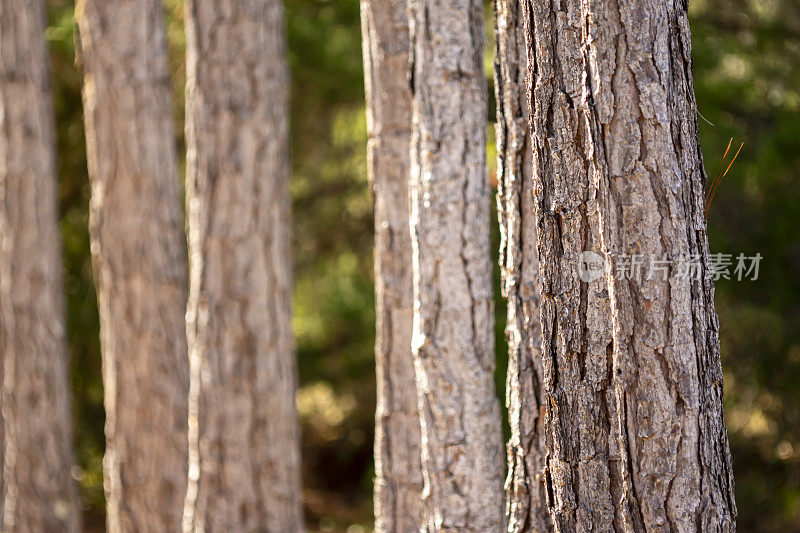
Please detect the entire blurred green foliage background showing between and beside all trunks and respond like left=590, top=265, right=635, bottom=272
left=47, top=0, right=800, bottom=533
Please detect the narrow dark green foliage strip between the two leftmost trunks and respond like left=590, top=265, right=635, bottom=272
left=46, top=0, right=105, bottom=528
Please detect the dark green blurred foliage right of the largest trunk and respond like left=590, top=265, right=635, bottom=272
left=691, top=0, right=800, bottom=532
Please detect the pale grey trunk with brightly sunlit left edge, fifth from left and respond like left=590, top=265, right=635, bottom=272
left=409, top=0, right=504, bottom=531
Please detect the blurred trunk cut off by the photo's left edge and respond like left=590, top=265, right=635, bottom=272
left=0, top=0, right=79, bottom=532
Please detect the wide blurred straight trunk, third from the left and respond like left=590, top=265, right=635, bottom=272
left=184, top=0, right=303, bottom=532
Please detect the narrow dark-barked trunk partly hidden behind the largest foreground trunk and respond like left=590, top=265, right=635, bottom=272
left=494, top=0, right=552, bottom=532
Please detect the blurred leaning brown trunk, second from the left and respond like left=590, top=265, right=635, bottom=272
left=76, top=0, right=188, bottom=531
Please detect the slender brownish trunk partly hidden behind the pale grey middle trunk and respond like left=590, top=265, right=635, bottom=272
left=361, top=0, right=422, bottom=533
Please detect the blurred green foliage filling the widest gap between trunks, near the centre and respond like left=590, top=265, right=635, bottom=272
left=285, top=0, right=375, bottom=529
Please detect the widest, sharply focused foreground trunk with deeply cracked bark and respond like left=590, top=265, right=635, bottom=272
left=523, top=0, right=735, bottom=532
